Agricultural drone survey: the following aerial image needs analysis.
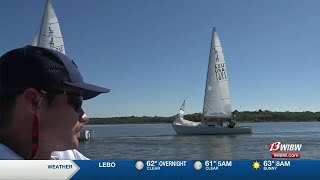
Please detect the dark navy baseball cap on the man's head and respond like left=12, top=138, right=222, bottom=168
left=0, top=46, right=110, bottom=100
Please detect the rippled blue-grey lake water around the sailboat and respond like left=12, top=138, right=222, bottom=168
left=78, top=122, right=320, bottom=160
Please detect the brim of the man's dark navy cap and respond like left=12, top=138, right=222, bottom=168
left=65, top=82, right=110, bottom=100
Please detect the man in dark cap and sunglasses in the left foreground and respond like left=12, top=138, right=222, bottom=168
left=0, top=46, right=110, bottom=160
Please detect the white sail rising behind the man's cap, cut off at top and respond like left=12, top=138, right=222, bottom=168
left=38, top=0, right=66, bottom=54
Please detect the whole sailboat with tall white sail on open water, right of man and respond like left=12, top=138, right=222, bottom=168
left=172, top=27, right=252, bottom=135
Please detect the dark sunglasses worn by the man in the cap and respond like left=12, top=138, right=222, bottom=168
left=44, top=90, right=84, bottom=117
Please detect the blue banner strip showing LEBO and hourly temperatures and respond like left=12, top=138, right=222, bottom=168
left=71, top=159, right=320, bottom=180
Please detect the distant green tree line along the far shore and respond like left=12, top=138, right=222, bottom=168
left=88, top=109, right=320, bottom=124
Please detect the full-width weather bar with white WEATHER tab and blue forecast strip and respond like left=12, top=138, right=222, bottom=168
left=0, top=159, right=320, bottom=180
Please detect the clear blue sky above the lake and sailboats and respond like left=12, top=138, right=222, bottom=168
left=0, top=0, right=320, bottom=117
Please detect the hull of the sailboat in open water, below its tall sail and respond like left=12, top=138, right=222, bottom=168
left=172, top=123, right=252, bottom=135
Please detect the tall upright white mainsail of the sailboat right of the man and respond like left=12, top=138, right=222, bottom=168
left=203, top=28, right=231, bottom=118
